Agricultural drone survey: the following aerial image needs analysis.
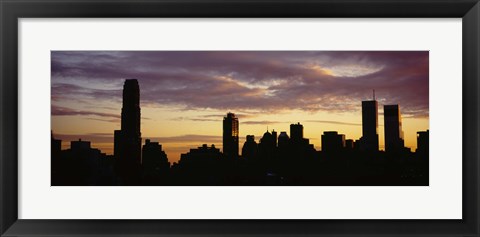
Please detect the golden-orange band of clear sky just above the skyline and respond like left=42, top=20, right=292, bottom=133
left=53, top=108, right=429, bottom=163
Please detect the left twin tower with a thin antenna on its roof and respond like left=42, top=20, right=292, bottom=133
left=360, top=94, right=378, bottom=152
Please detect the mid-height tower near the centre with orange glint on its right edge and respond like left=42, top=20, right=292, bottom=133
left=223, top=113, right=238, bottom=158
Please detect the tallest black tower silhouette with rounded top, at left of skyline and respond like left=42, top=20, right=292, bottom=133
left=114, top=79, right=142, bottom=185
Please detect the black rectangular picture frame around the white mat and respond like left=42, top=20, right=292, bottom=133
left=0, top=0, right=480, bottom=236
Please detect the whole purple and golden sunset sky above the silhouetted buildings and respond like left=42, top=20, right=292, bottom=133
left=51, top=51, right=429, bottom=162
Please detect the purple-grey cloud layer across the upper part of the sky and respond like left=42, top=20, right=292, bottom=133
left=52, top=51, right=429, bottom=119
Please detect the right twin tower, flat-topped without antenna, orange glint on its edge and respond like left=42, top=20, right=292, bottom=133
left=383, top=105, right=404, bottom=152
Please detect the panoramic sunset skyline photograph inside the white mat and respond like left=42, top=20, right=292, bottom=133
left=50, top=50, right=430, bottom=186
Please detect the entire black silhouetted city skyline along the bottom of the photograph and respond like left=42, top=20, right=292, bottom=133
left=51, top=82, right=429, bottom=186
